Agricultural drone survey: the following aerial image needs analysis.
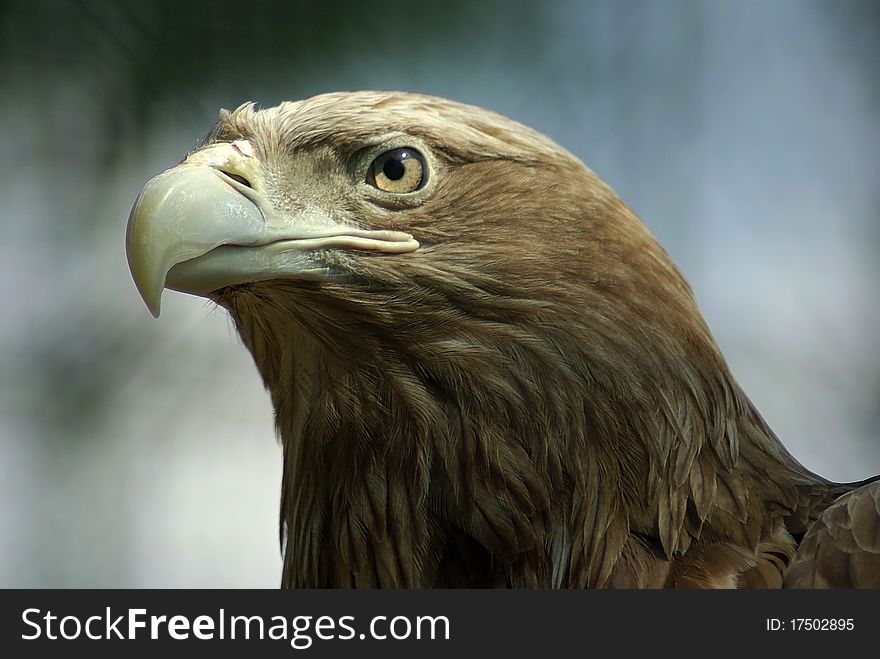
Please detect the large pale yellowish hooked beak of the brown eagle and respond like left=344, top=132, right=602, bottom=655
left=126, top=140, right=419, bottom=317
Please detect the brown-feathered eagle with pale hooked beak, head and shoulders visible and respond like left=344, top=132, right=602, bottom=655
left=127, top=92, right=880, bottom=588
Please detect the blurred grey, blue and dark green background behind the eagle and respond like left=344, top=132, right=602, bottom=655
left=0, top=0, right=880, bottom=587
